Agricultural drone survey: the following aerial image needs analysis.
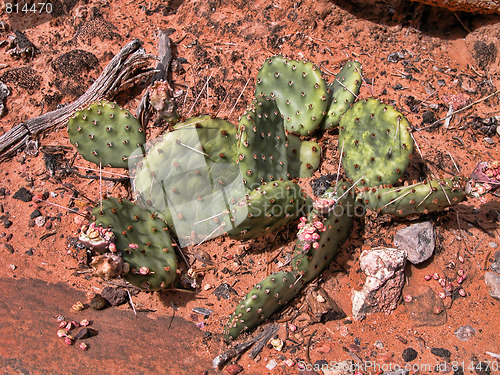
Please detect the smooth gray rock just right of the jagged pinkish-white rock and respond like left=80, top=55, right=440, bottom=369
left=394, top=221, right=436, bottom=264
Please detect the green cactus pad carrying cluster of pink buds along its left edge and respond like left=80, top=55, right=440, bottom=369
left=292, top=182, right=354, bottom=283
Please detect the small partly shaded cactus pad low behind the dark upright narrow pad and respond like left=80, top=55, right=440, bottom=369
left=286, top=134, right=321, bottom=179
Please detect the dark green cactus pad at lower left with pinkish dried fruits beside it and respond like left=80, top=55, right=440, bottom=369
left=92, top=198, right=177, bottom=290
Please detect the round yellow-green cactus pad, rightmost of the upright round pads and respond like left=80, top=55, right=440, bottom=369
left=339, top=99, right=413, bottom=186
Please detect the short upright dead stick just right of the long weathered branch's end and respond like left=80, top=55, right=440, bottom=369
left=135, top=30, right=172, bottom=127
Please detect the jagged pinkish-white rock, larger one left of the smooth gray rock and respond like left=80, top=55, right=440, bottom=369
left=351, top=249, right=406, bottom=320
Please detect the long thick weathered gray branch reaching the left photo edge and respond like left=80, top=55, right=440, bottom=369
left=0, top=39, right=154, bottom=160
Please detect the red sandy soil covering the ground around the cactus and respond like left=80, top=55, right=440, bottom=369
left=0, top=0, right=500, bottom=374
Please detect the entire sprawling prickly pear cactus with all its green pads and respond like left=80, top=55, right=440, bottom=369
left=68, top=56, right=464, bottom=340
